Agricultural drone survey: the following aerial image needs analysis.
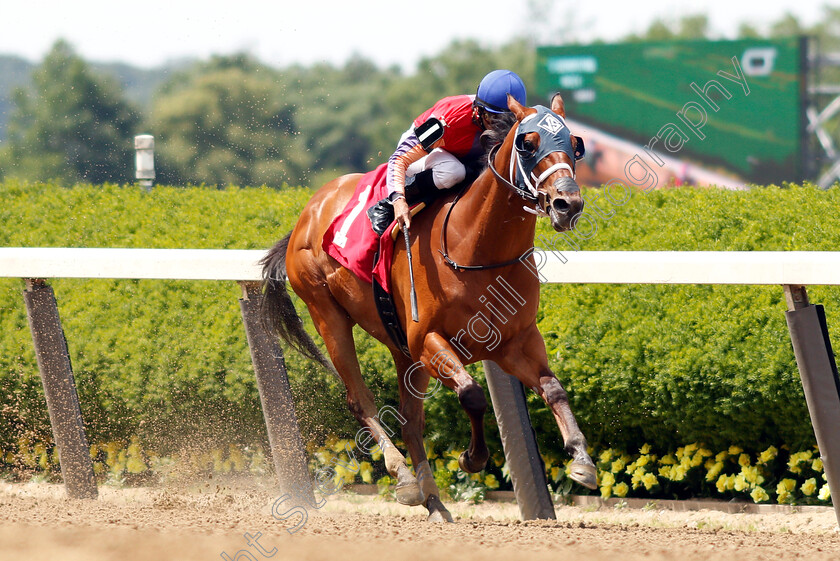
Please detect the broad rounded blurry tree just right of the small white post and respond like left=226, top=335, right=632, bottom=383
left=151, top=55, right=310, bottom=187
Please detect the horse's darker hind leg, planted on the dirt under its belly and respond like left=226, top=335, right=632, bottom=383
left=391, top=351, right=452, bottom=522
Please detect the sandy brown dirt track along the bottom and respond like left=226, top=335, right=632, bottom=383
left=0, top=476, right=840, bottom=561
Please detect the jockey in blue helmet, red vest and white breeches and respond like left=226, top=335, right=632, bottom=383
left=387, top=70, right=526, bottom=227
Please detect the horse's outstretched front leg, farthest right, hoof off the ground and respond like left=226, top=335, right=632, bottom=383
left=496, top=325, right=598, bottom=489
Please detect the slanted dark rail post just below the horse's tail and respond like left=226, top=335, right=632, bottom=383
left=239, top=282, right=315, bottom=504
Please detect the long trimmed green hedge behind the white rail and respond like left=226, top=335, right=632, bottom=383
left=0, top=182, right=840, bottom=460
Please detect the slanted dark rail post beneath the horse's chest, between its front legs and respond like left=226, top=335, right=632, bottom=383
left=484, top=360, right=556, bottom=520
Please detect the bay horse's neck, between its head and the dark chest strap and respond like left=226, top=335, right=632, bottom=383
left=458, top=143, right=537, bottom=258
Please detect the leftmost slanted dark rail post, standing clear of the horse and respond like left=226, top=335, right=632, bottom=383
left=23, top=279, right=99, bottom=499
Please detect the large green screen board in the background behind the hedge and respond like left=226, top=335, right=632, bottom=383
left=536, top=37, right=807, bottom=184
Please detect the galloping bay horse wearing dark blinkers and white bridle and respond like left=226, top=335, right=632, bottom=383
left=261, top=96, right=596, bottom=522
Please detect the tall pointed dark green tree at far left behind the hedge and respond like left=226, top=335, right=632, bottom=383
left=0, top=40, right=139, bottom=183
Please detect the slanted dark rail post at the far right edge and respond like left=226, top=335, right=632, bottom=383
left=785, top=285, right=840, bottom=526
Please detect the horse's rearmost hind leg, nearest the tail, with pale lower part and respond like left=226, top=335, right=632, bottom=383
left=306, top=293, right=423, bottom=506
